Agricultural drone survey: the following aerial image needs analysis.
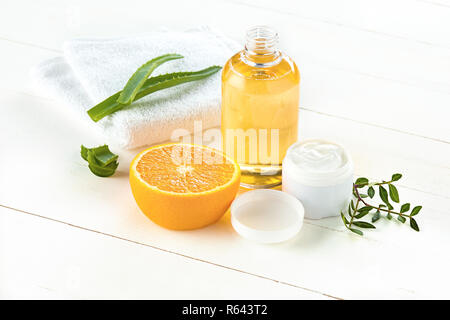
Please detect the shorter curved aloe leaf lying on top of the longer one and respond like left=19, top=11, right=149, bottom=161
left=117, top=53, right=183, bottom=104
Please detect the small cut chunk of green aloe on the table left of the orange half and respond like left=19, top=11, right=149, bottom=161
left=81, top=145, right=119, bottom=177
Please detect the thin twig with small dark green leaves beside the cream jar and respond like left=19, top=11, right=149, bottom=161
left=341, top=173, right=422, bottom=236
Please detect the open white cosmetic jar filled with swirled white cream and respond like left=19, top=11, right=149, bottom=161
left=282, top=139, right=353, bottom=219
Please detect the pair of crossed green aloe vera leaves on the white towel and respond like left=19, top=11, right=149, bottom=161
left=87, top=53, right=222, bottom=122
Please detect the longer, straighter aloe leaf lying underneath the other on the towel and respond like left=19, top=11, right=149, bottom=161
left=87, top=66, right=222, bottom=122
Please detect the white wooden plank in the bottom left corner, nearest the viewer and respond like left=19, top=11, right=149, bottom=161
left=0, top=207, right=329, bottom=299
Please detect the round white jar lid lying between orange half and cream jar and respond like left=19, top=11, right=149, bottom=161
left=230, top=189, right=305, bottom=243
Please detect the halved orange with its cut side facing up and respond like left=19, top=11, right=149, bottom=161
left=130, top=143, right=241, bottom=230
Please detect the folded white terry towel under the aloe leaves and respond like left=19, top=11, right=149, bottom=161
left=31, top=27, right=239, bottom=149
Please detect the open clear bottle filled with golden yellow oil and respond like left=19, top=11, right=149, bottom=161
left=221, top=27, right=300, bottom=188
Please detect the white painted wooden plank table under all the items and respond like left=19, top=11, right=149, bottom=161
left=0, top=0, right=450, bottom=299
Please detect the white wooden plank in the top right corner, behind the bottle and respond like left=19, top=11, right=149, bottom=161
left=230, top=0, right=450, bottom=48
